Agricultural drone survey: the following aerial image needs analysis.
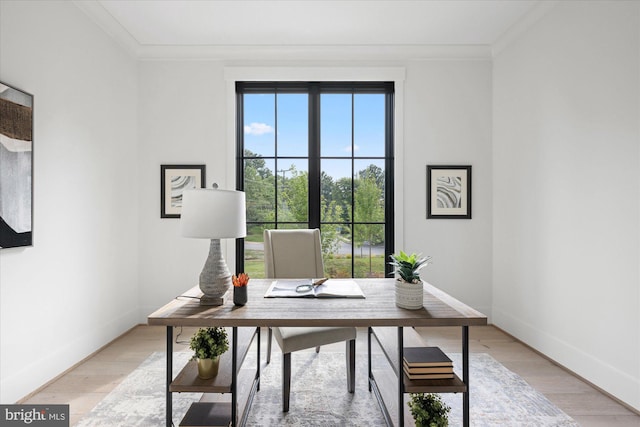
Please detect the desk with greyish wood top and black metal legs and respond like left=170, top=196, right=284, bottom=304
left=148, top=278, right=487, bottom=427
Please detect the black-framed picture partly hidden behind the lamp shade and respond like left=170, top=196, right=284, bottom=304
left=160, top=165, right=206, bottom=218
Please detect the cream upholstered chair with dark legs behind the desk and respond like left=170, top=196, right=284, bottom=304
left=264, top=229, right=356, bottom=412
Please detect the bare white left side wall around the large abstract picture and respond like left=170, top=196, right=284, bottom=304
left=0, top=1, right=139, bottom=403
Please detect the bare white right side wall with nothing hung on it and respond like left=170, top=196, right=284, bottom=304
left=493, top=1, right=640, bottom=409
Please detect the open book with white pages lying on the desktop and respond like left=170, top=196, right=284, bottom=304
left=264, top=279, right=364, bottom=298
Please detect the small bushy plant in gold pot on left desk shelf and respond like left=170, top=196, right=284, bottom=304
left=189, top=327, right=229, bottom=380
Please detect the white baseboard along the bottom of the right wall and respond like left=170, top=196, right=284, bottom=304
left=492, top=308, right=640, bottom=415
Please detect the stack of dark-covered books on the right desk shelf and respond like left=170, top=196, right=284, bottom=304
left=402, top=347, right=454, bottom=380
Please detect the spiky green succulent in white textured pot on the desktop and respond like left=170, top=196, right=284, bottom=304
left=389, top=251, right=431, bottom=310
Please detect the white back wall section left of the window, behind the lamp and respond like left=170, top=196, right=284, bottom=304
left=138, top=61, right=230, bottom=314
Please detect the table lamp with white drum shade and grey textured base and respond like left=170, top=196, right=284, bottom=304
left=180, top=189, right=247, bottom=305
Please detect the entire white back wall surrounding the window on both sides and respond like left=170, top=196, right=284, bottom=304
left=139, top=60, right=492, bottom=319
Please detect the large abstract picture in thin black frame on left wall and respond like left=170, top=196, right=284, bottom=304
left=0, top=83, right=33, bottom=249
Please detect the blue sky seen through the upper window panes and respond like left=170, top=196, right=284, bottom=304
left=244, top=94, right=384, bottom=178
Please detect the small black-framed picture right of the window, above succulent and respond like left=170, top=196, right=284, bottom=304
left=427, top=165, right=471, bottom=219
